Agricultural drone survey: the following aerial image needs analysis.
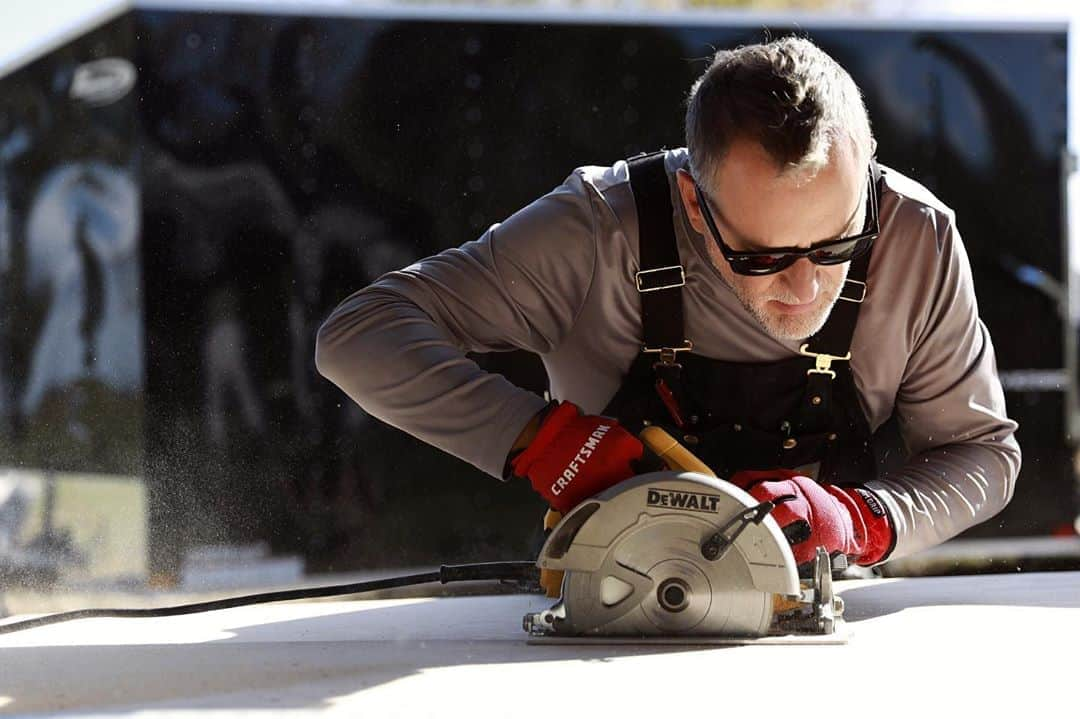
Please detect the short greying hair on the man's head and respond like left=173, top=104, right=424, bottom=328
left=686, top=37, right=874, bottom=190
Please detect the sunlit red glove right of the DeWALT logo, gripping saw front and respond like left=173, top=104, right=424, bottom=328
left=730, top=470, right=893, bottom=566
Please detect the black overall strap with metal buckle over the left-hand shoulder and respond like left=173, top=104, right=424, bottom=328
left=627, top=150, right=693, bottom=364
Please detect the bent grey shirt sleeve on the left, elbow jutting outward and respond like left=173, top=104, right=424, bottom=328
left=315, top=173, right=597, bottom=477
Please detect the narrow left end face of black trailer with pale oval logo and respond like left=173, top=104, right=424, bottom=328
left=0, top=17, right=144, bottom=475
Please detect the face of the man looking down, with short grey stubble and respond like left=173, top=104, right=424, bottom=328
left=678, top=140, right=866, bottom=340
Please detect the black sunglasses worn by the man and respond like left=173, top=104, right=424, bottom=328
left=693, top=168, right=880, bottom=275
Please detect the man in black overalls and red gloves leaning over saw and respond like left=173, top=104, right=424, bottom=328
left=316, top=38, right=1021, bottom=565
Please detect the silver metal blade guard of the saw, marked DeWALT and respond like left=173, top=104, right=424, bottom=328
left=537, top=472, right=800, bottom=636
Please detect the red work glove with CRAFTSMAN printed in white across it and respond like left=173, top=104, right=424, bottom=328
left=510, top=402, right=645, bottom=514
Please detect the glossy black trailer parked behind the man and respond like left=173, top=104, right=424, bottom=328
left=6, top=11, right=1075, bottom=570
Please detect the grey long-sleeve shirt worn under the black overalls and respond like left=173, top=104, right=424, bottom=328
left=315, top=150, right=1021, bottom=558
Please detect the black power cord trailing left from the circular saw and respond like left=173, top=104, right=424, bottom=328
left=0, top=561, right=540, bottom=634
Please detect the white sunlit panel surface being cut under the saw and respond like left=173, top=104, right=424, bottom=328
left=0, top=572, right=1080, bottom=719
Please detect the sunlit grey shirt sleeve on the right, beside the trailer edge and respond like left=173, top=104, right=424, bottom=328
left=867, top=209, right=1021, bottom=558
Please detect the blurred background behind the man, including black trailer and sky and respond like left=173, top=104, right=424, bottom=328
left=0, top=0, right=1080, bottom=615
